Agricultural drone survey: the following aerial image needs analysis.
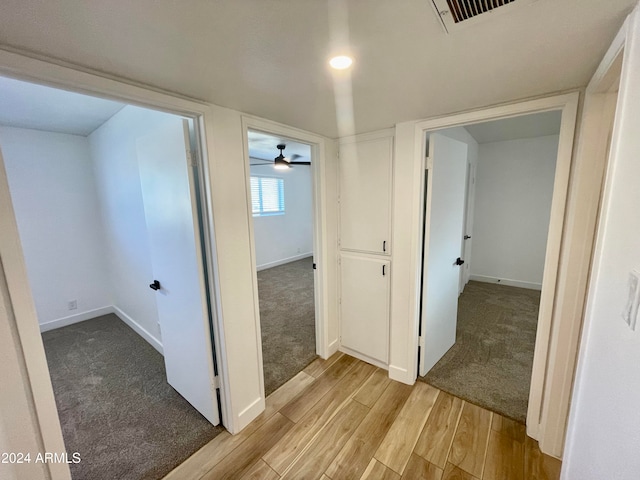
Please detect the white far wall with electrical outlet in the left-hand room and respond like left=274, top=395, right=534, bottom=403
left=0, top=127, right=111, bottom=330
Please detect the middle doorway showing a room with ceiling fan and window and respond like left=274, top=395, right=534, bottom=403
left=247, top=129, right=317, bottom=396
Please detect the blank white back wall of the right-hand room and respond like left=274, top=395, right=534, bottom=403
left=471, top=135, right=559, bottom=289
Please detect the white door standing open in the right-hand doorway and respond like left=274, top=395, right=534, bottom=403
left=420, top=133, right=467, bottom=375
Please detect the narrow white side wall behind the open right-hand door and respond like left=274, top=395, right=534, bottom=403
left=437, top=127, right=478, bottom=285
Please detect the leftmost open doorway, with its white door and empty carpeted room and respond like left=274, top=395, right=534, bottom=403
left=0, top=78, right=222, bottom=478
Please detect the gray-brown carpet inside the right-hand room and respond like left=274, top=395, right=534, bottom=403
left=419, top=282, right=540, bottom=423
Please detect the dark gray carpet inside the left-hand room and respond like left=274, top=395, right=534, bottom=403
left=42, top=315, right=223, bottom=480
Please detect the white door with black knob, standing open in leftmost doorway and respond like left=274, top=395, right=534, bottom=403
left=137, top=117, right=220, bottom=425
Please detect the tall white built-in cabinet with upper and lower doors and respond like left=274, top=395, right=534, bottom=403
left=338, top=130, right=393, bottom=366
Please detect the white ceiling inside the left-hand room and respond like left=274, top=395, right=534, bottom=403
left=0, top=77, right=124, bottom=136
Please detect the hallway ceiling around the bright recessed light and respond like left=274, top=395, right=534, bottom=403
left=0, top=0, right=636, bottom=137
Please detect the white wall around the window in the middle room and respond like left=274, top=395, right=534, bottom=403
left=251, top=165, right=313, bottom=270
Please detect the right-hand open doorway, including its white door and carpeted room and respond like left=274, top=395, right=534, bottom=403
left=420, top=111, right=561, bottom=423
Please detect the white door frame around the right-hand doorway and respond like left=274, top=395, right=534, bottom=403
left=405, top=91, right=584, bottom=457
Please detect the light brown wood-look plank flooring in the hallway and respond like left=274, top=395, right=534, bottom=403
left=165, top=353, right=560, bottom=480
